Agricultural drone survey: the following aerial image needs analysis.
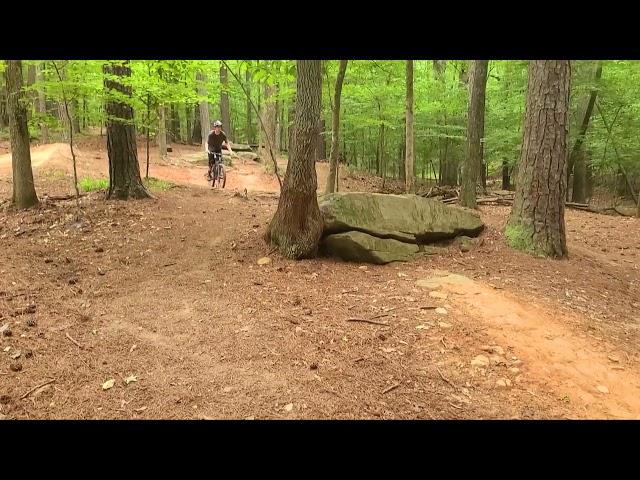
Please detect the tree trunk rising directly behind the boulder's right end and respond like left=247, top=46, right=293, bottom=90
left=460, top=60, right=489, bottom=208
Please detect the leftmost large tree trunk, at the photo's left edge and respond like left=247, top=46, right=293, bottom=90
left=5, top=60, right=38, bottom=209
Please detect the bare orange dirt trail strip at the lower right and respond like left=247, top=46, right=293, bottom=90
left=420, top=274, right=640, bottom=419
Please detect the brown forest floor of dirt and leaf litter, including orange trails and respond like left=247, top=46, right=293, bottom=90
left=0, top=137, right=640, bottom=419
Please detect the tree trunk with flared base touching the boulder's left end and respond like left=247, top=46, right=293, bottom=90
left=266, top=60, right=323, bottom=259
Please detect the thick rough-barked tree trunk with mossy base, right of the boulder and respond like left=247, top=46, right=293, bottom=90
left=506, top=60, right=571, bottom=258
